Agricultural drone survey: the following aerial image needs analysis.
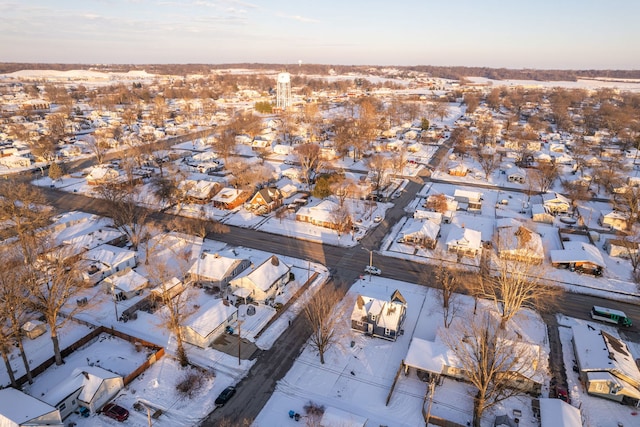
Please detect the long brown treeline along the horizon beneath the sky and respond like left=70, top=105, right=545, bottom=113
left=0, top=62, right=640, bottom=81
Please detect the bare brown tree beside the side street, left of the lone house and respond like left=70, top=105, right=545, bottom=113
left=303, top=286, right=352, bottom=365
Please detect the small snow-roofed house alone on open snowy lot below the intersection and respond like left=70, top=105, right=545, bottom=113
left=351, top=289, right=407, bottom=341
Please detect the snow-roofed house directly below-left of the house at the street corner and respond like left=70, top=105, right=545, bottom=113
left=181, top=299, right=238, bottom=348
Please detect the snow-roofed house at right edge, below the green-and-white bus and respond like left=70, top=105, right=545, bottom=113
left=571, top=325, right=640, bottom=405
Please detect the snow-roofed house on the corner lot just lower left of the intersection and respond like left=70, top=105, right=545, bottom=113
left=229, top=255, right=293, bottom=301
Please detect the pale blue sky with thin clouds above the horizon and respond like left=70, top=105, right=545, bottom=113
left=0, top=0, right=640, bottom=69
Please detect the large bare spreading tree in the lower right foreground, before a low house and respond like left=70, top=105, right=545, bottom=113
left=440, top=314, right=540, bottom=427
